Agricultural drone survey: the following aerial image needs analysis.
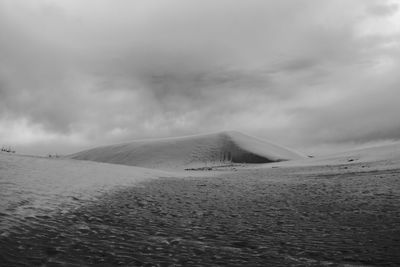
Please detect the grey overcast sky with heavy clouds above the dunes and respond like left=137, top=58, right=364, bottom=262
left=0, top=0, right=400, bottom=154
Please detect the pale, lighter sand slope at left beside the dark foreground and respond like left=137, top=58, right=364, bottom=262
left=0, top=153, right=168, bottom=234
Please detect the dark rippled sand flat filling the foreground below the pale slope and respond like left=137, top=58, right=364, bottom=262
left=0, top=160, right=400, bottom=266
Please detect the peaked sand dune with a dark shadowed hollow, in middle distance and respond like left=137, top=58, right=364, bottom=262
left=69, top=131, right=304, bottom=169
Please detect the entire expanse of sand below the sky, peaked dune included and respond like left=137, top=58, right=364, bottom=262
left=0, top=137, right=400, bottom=266
